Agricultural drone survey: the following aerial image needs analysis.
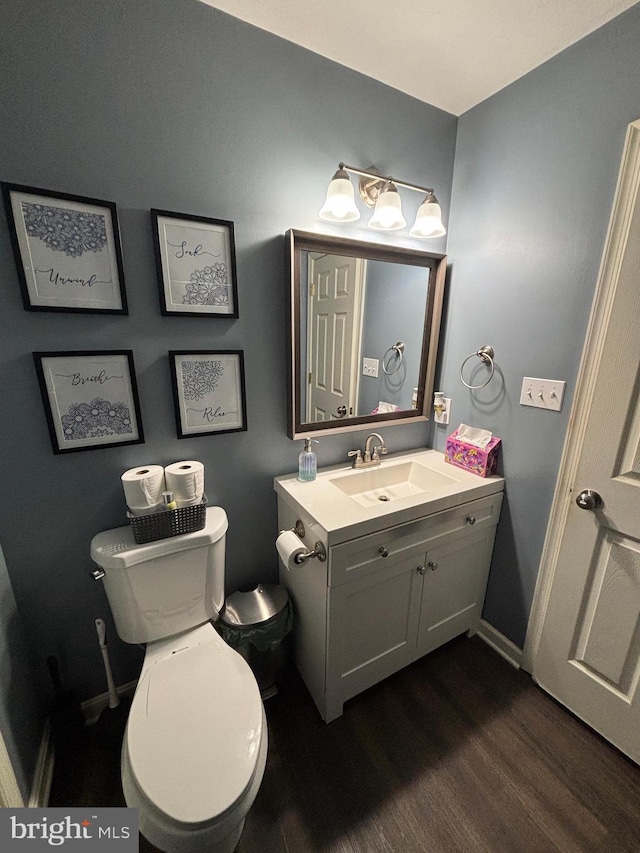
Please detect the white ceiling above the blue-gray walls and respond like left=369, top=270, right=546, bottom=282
left=203, top=0, right=638, bottom=115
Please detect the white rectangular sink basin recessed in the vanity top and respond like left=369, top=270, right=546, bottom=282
left=330, top=462, right=458, bottom=507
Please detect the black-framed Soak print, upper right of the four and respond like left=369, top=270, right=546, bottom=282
left=151, top=210, right=238, bottom=317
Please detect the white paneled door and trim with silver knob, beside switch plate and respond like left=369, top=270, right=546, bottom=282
left=525, top=121, right=640, bottom=762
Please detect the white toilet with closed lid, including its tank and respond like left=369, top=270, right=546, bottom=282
left=91, top=507, right=267, bottom=853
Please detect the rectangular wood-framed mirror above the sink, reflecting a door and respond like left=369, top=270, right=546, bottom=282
left=287, top=230, right=446, bottom=438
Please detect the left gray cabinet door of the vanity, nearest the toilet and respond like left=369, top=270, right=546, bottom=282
left=327, top=548, right=424, bottom=705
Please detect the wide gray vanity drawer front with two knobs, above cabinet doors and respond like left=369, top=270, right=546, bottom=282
left=329, top=492, right=502, bottom=586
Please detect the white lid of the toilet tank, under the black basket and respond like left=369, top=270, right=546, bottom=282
left=91, top=506, right=229, bottom=569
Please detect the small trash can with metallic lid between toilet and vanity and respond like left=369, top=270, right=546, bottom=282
left=219, top=583, right=293, bottom=699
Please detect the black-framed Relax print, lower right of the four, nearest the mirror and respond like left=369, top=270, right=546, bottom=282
left=169, top=350, right=247, bottom=438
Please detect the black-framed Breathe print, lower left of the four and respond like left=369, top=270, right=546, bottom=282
left=33, top=350, right=144, bottom=453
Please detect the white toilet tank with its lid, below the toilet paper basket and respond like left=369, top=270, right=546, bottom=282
left=91, top=506, right=228, bottom=643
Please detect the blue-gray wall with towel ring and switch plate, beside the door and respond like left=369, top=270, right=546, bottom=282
left=435, top=7, right=640, bottom=645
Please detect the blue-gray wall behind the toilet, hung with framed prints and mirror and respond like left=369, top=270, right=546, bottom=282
left=0, top=0, right=456, bottom=698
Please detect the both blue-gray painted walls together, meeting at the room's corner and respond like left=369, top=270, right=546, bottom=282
left=5, top=0, right=640, bottom=716
